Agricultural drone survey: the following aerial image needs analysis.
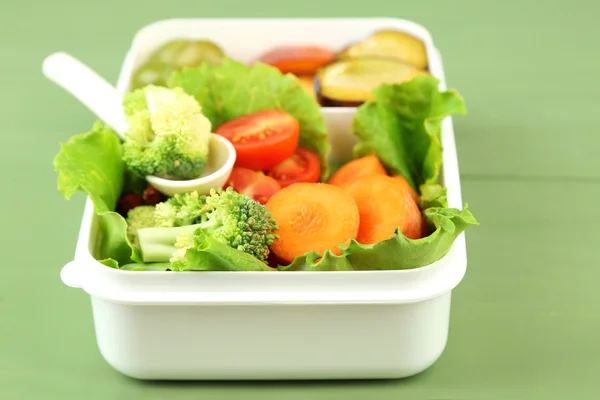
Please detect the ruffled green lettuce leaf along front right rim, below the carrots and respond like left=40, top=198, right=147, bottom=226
left=278, top=205, right=479, bottom=271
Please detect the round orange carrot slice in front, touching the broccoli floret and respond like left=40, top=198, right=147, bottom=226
left=267, top=182, right=360, bottom=263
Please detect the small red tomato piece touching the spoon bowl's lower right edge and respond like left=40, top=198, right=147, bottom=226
left=223, top=167, right=281, bottom=204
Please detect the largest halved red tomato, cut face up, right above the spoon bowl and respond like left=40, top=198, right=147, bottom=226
left=215, top=110, right=300, bottom=171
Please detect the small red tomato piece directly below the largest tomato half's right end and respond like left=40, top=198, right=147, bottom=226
left=267, top=147, right=321, bottom=187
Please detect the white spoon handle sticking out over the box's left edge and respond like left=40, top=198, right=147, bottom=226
left=42, top=52, right=128, bottom=138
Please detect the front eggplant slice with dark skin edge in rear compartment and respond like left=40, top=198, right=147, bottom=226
left=315, top=57, right=428, bottom=107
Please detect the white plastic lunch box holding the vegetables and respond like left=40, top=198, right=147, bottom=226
left=61, top=18, right=467, bottom=380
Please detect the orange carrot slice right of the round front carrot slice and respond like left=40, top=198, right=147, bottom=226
left=344, top=175, right=424, bottom=244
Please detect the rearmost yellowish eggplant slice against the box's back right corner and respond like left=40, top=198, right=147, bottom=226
left=338, top=30, right=428, bottom=70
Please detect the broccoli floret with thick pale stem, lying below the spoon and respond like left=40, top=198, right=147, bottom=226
left=138, top=187, right=278, bottom=262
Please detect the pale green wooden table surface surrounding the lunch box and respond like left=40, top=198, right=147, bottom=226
left=0, top=0, right=600, bottom=400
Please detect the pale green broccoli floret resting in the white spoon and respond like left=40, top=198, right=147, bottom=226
left=123, top=85, right=212, bottom=179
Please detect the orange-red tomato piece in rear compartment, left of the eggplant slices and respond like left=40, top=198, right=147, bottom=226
left=258, top=46, right=336, bottom=75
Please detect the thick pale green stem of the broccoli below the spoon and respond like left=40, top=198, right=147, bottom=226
left=137, top=224, right=203, bottom=263
